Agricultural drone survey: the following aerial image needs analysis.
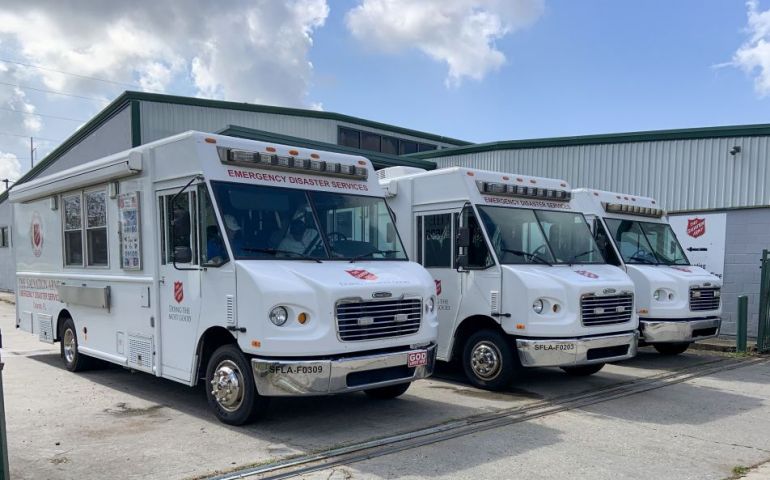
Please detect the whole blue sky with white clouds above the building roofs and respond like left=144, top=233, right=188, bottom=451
left=0, top=0, right=770, bottom=188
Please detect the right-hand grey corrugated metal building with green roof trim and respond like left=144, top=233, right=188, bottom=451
left=410, top=125, right=770, bottom=335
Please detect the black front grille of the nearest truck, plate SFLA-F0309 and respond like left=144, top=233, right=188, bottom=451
left=336, top=298, right=422, bottom=342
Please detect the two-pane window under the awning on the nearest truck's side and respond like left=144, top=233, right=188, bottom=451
left=61, top=190, right=109, bottom=267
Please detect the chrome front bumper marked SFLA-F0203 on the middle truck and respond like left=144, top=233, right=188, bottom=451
left=516, top=332, right=639, bottom=367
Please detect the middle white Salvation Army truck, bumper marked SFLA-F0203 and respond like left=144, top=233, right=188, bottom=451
left=378, top=167, right=638, bottom=389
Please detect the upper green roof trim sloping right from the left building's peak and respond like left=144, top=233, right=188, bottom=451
left=130, top=91, right=471, bottom=146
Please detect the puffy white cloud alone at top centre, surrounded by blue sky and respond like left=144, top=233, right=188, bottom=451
left=346, top=0, right=544, bottom=86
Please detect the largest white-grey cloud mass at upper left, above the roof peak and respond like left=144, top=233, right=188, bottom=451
left=0, top=0, right=329, bottom=106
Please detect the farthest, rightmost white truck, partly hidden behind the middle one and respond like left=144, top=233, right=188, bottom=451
left=573, top=189, right=722, bottom=355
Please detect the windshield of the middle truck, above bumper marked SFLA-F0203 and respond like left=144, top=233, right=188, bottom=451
left=479, top=205, right=605, bottom=264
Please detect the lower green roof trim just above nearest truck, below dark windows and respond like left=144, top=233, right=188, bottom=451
left=216, top=125, right=436, bottom=170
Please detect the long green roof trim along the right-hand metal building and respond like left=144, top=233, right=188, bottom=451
left=407, top=124, right=770, bottom=158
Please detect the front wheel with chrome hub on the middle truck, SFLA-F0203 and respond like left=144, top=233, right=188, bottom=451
left=463, top=330, right=518, bottom=390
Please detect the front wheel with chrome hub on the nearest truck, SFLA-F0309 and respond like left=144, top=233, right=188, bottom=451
left=206, top=345, right=269, bottom=425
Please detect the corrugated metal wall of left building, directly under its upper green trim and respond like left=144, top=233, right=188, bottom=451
left=140, top=102, right=455, bottom=147
